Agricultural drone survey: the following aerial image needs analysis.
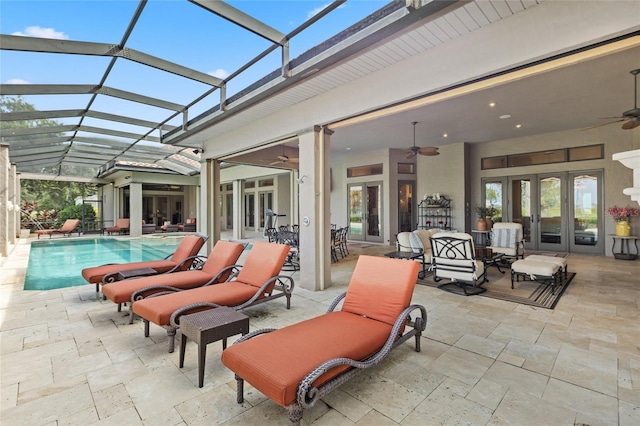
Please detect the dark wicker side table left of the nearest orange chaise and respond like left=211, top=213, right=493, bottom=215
left=180, top=306, right=249, bottom=387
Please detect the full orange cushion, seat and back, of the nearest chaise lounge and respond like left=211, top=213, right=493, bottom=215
left=222, top=255, right=420, bottom=407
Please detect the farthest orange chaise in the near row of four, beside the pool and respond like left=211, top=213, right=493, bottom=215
left=82, top=235, right=208, bottom=293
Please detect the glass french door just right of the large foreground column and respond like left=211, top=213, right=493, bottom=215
left=348, top=182, right=383, bottom=242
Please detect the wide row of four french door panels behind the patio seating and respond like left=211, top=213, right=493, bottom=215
left=483, top=171, right=604, bottom=254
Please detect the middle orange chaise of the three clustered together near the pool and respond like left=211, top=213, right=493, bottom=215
left=102, top=240, right=245, bottom=322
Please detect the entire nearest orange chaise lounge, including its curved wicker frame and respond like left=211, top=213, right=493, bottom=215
left=222, top=255, right=427, bottom=424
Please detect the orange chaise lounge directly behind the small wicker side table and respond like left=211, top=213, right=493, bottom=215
left=131, top=241, right=294, bottom=352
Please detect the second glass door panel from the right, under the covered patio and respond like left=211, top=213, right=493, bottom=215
left=538, top=176, right=567, bottom=251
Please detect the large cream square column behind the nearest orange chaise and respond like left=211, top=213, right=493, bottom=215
left=298, top=126, right=333, bottom=291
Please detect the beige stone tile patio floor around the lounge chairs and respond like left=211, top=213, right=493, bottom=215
left=0, top=235, right=640, bottom=426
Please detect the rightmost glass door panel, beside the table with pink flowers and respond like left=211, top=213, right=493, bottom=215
left=570, top=172, right=603, bottom=254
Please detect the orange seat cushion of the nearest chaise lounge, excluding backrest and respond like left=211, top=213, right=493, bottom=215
left=221, top=312, right=390, bottom=407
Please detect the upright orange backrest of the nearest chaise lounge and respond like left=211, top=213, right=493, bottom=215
left=342, top=255, right=420, bottom=326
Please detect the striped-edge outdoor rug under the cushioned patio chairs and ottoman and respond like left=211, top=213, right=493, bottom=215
left=417, top=266, right=576, bottom=309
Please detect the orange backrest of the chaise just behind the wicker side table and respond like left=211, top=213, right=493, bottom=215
left=237, top=241, right=289, bottom=293
